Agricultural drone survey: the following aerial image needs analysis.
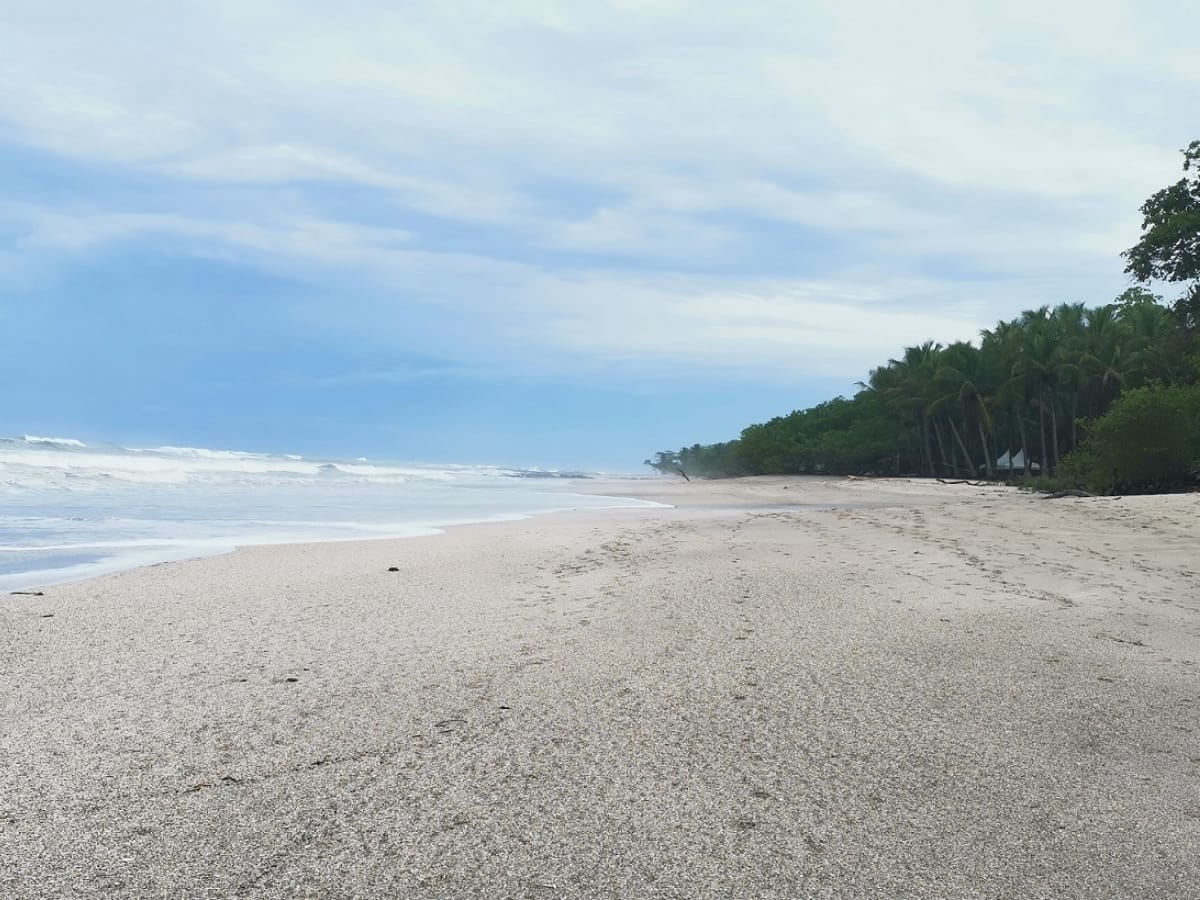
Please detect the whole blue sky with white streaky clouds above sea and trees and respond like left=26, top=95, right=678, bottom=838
left=0, top=0, right=1200, bottom=470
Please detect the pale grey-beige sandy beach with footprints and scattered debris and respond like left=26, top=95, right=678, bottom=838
left=0, top=479, right=1200, bottom=900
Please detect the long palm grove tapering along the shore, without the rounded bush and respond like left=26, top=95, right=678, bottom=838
left=646, top=288, right=1196, bottom=486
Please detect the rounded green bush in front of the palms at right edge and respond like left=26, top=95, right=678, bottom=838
left=1061, top=384, right=1200, bottom=492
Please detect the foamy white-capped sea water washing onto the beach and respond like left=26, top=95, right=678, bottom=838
left=0, top=436, right=659, bottom=592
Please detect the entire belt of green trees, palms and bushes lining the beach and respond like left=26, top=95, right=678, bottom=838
left=646, top=142, right=1200, bottom=491
